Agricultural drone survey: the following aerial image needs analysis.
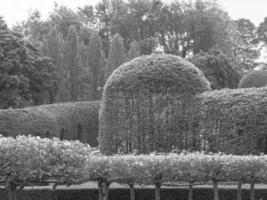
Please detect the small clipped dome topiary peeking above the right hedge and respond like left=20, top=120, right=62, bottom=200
left=238, top=70, right=267, bottom=88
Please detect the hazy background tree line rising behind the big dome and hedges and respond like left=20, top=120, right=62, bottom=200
left=1, top=0, right=267, bottom=108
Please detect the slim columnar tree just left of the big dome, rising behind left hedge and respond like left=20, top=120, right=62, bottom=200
left=88, top=33, right=103, bottom=100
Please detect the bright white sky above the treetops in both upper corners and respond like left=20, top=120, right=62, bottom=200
left=0, top=0, right=267, bottom=26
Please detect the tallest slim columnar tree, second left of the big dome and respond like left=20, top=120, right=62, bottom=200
left=65, top=26, right=79, bottom=101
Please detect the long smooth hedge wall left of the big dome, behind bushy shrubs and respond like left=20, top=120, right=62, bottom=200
left=0, top=102, right=99, bottom=146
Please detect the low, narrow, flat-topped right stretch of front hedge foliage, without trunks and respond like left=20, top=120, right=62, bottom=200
left=85, top=153, right=267, bottom=185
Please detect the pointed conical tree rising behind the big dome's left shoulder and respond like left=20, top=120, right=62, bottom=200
left=105, top=34, right=126, bottom=78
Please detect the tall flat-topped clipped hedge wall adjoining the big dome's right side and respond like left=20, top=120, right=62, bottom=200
left=191, top=87, right=267, bottom=154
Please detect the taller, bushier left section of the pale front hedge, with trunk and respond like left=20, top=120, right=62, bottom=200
left=0, top=136, right=91, bottom=200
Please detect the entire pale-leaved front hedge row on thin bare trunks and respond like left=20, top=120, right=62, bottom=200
left=0, top=136, right=267, bottom=200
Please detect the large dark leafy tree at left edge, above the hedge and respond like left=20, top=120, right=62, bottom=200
left=0, top=18, right=56, bottom=108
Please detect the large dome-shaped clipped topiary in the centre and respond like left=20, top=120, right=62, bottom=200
left=99, top=54, right=210, bottom=154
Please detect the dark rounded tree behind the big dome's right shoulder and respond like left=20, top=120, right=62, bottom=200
left=190, top=51, right=240, bottom=89
